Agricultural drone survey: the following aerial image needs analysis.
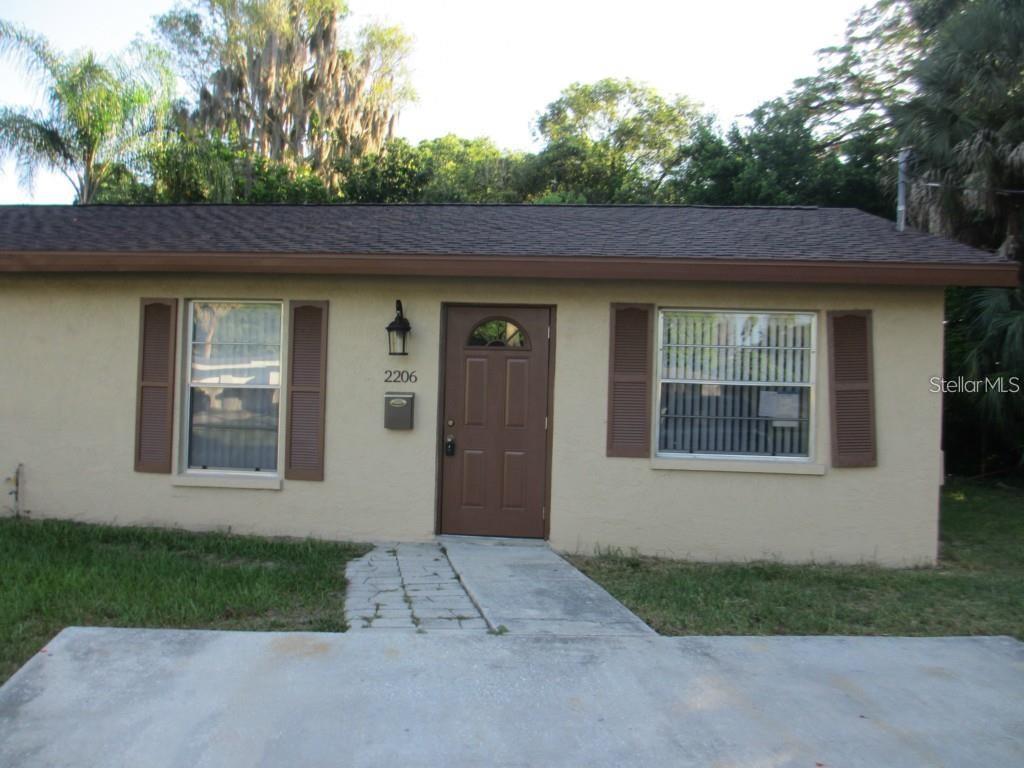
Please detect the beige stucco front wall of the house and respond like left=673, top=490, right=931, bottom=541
left=0, top=275, right=942, bottom=564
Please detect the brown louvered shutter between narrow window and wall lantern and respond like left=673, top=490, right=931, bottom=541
left=285, top=301, right=327, bottom=480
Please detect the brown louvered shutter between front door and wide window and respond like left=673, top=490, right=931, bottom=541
left=607, top=304, right=654, bottom=458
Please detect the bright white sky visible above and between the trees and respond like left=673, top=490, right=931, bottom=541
left=0, top=0, right=866, bottom=204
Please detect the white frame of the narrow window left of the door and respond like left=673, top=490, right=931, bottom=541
left=179, top=298, right=286, bottom=479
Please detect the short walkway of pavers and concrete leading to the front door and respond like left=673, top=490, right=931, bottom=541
left=345, top=537, right=653, bottom=637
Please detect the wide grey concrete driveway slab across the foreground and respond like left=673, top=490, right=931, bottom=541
left=0, top=629, right=1024, bottom=768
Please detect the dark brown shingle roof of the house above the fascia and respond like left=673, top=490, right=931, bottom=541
left=0, top=205, right=1007, bottom=265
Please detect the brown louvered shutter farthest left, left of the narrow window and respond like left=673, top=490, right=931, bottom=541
left=135, top=299, right=178, bottom=474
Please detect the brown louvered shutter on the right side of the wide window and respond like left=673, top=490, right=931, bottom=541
left=828, top=309, right=878, bottom=467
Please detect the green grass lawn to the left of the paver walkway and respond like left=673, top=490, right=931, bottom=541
left=0, top=517, right=368, bottom=682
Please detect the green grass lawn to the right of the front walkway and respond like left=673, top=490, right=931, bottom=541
left=570, top=481, right=1024, bottom=639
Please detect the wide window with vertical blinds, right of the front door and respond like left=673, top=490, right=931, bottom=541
left=657, top=310, right=815, bottom=459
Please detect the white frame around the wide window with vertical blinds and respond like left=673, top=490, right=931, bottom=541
left=650, top=306, right=818, bottom=464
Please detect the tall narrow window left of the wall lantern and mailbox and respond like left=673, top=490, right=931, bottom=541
left=185, top=301, right=282, bottom=472
